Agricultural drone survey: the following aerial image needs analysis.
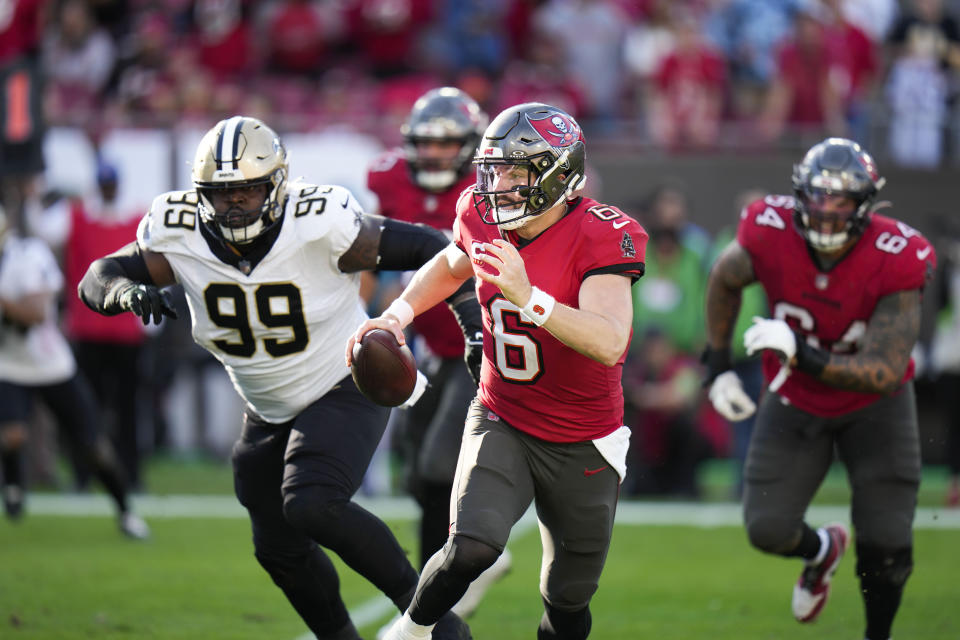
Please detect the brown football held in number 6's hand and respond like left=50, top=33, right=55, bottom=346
left=350, top=329, right=417, bottom=407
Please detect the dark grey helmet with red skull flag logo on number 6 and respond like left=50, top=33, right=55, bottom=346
left=473, top=102, right=586, bottom=230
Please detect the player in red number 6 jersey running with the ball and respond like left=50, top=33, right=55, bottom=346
left=346, top=103, right=647, bottom=640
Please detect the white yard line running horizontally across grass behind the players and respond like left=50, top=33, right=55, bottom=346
left=26, top=493, right=960, bottom=535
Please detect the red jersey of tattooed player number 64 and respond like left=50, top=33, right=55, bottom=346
left=737, top=195, right=936, bottom=417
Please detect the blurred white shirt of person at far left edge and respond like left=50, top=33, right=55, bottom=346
left=0, top=235, right=77, bottom=386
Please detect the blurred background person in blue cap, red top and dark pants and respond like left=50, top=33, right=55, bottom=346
left=64, top=162, right=144, bottom=488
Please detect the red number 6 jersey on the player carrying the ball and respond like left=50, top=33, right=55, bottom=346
left=454, top=191, right=647, bottom=442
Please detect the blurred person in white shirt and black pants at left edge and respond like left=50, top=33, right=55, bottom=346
left=0, top=208, right=150, bottom=539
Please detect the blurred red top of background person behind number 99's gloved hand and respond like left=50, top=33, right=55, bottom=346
left=64, top=201, right=144, bottom=344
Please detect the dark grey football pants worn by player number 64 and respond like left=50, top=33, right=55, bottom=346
left=744, top=383, right=920, bottom=552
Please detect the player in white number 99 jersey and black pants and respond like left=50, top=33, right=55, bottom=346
left=79, top=116, right=480, bottom=640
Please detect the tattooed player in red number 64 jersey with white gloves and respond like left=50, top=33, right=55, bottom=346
left=705, top=138, right=936, bottom=640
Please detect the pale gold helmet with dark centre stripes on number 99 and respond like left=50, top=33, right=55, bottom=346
left=193, top=116, right=288, bottom=244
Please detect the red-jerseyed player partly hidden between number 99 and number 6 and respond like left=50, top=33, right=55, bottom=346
left=367, top=87, right=487, bottom=567
